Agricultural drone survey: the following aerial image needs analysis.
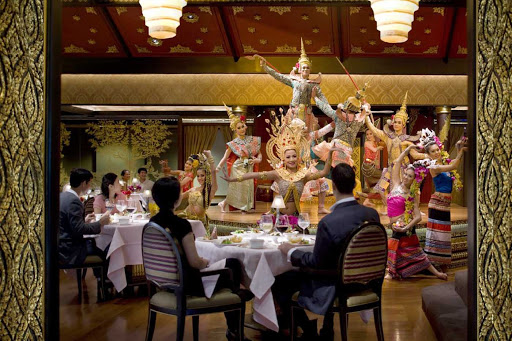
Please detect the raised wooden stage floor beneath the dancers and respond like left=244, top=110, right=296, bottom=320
left=208, top=200, right=468, bottom=225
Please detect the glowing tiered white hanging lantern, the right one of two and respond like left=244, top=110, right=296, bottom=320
left=370, top=0, right=420, bottom=43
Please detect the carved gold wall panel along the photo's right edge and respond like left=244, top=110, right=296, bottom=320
left=476, top=0, right=512, bottom=340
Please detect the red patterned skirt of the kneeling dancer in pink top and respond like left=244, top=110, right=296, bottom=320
left=388, top=228, right=431, bottom=278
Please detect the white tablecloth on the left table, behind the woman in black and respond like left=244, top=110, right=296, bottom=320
left=96, top=220, right=206, bottom=291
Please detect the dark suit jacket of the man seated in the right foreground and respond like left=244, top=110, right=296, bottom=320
left=291, top=200, right=380, bottom=315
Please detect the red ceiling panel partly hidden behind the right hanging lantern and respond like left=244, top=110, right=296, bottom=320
left=343, top=7, right=454, bottom=58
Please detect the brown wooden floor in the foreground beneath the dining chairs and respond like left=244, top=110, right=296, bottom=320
left=60, top=269, right=461, bottom=341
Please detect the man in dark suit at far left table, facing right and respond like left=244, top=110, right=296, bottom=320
left=59, top=168, right=110, bottom=265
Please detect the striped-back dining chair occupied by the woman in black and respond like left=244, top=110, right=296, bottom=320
left=142, top=222, right=245, bottom=341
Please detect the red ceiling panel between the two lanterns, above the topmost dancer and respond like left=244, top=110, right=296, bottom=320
left=225, top=6, right=338, bottom=56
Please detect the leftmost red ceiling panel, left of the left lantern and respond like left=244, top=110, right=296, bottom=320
left=62, top=7, right=126, bottom=57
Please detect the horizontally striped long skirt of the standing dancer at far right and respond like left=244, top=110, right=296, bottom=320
left=425, top=194, right=452, bottom=265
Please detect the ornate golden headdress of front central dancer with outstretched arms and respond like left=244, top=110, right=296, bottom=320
left=265, top=111, right=310, bottom=169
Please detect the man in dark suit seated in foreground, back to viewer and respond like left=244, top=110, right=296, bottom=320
left=274, top=163, right=380, bottom=339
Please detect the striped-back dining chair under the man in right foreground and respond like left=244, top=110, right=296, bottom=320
left=290, top=222, right=388, bottom=341
